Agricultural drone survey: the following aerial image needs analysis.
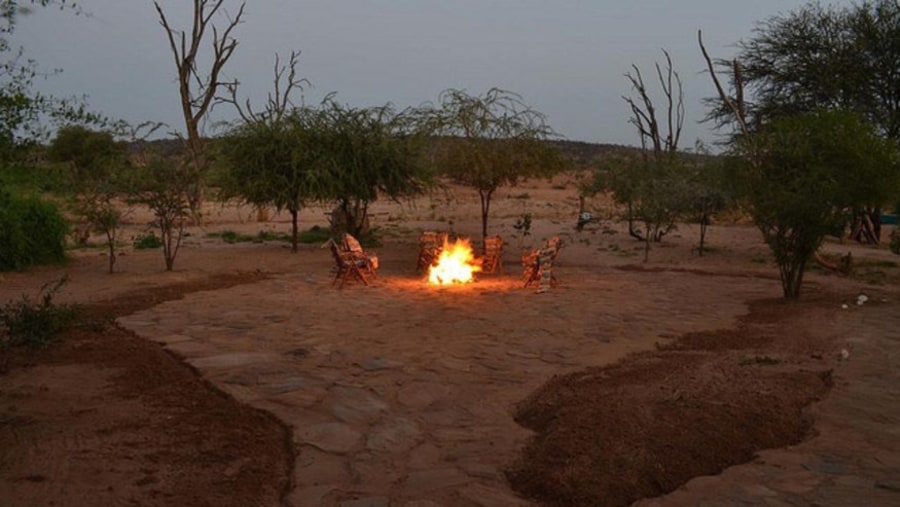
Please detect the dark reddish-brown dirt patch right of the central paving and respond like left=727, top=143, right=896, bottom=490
left=507, top=302, right=831, bottom=506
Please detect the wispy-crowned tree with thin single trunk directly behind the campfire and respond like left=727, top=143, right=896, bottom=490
left=431, top=88, right=565, bottom=253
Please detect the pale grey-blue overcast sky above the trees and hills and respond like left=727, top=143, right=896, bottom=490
left=14, top=0, right=850, bottom=148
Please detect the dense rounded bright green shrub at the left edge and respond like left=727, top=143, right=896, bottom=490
left=0, top=192, right=69, bottom=271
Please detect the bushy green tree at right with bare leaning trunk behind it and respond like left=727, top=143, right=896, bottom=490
left=698, top=32, right=900, bottom=299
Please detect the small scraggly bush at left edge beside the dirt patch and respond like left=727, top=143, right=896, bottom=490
left=0, top=278, right=80, bottom=349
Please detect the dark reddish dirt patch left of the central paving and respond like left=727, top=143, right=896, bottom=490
left=0, top=274, right=293, bottom=506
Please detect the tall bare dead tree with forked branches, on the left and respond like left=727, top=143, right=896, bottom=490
left=153, top=0, right=245, bottom=221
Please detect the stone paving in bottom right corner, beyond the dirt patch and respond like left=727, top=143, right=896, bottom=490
left=635, top=302, right=900, bottom=507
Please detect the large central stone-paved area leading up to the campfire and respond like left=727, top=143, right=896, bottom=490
left=119, top=267, right=773, bottom=507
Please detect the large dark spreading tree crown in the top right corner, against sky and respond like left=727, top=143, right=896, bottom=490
left=710, top=0, right=900, bottom=243
